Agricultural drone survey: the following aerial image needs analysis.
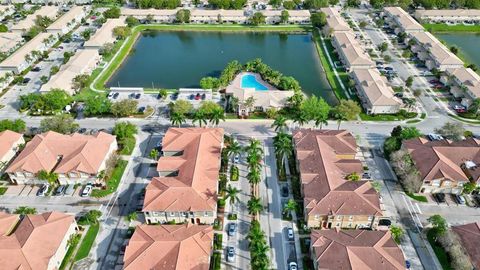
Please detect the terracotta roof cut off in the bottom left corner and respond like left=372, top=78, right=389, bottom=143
left=0, top=212, right=75, bottom=270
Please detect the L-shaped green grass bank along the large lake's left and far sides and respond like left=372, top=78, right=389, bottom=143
left=92, top=24, right=311, bottom=90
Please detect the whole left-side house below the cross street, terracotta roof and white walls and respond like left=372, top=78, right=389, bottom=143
left=6, top=131, right=117, bottom=184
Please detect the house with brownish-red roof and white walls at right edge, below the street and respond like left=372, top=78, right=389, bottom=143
left=402, top=138, right=480, bottom=194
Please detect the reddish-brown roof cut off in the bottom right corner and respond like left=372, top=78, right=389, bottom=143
left=452, top=222, right=480, bottom=269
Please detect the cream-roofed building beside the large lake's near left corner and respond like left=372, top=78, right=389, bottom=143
left=40, top=49, right=100, bottom=95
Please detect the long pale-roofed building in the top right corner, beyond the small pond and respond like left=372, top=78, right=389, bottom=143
left=414, top=9, right=480, bottom=23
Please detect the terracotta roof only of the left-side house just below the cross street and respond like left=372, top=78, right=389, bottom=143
left=6, top=131, right=115, bottom=174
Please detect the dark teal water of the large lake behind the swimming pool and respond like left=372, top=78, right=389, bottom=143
left=107, top=31, right=336, bottom=103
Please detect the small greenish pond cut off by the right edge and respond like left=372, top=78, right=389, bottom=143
left=435, top=33, right=480, bottom=67
